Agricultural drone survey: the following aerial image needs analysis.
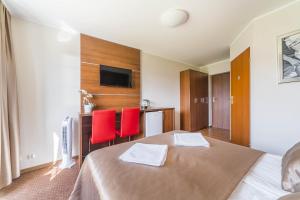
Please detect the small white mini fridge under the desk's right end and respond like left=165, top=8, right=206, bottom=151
left=145, top=111, right=163, bottom=137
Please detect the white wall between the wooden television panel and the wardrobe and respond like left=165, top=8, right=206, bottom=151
left=141, top=53, right=198, bottom=129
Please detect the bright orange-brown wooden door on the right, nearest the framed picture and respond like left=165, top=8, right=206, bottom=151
left=231, top=48, right=250, bottom=146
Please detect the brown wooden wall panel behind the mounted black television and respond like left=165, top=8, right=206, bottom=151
left=80, top=34, right=140, bottom=111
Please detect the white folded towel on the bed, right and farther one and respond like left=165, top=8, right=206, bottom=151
left=174, top=133, right=209, bottom=147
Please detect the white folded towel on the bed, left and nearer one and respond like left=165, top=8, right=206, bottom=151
left=119, top=143, right=168, bottom=167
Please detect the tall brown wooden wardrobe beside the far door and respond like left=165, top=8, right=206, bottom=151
left=180, top=70, right=208, bottom=131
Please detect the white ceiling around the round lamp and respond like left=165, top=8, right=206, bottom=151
left=5, top=0, right=293, bottom=66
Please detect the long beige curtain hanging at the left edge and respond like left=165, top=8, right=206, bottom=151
left=0, top=0, right=20, bottom=189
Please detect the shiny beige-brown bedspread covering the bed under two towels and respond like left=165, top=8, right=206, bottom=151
left=70, top=133, right=262, bottom=200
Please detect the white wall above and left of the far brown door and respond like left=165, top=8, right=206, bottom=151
left=199, top=59, right=230, bottom=126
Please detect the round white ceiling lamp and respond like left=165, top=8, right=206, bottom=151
left=160, top=9, right=189, bottom=27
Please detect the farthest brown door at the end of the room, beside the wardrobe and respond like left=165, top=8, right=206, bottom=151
left=212, top=72, right=230, bottom=130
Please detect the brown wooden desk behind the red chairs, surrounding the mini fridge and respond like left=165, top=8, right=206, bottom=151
left=79, top=108, right=175, bottom=165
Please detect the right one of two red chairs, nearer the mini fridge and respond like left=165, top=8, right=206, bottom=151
left=117, top=108, right=140, bottom=141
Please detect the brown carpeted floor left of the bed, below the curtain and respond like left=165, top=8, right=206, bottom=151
left=0, top=164, right=79, bottom=200
